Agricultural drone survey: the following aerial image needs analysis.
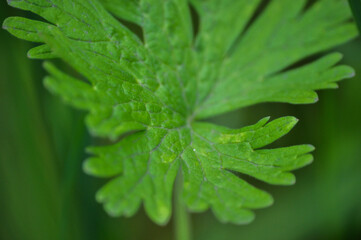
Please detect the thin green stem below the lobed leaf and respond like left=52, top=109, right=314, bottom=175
left=174, top=173, right=191, bottom=240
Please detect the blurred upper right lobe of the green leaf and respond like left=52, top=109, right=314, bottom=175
left=193, top=0, right=357, bottom=117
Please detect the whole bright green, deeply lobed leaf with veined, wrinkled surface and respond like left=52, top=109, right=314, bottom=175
left=3, top=0, right=357, bottom=224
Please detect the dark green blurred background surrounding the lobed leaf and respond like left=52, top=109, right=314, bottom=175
left=0, top=1, right=361, bottom=240
